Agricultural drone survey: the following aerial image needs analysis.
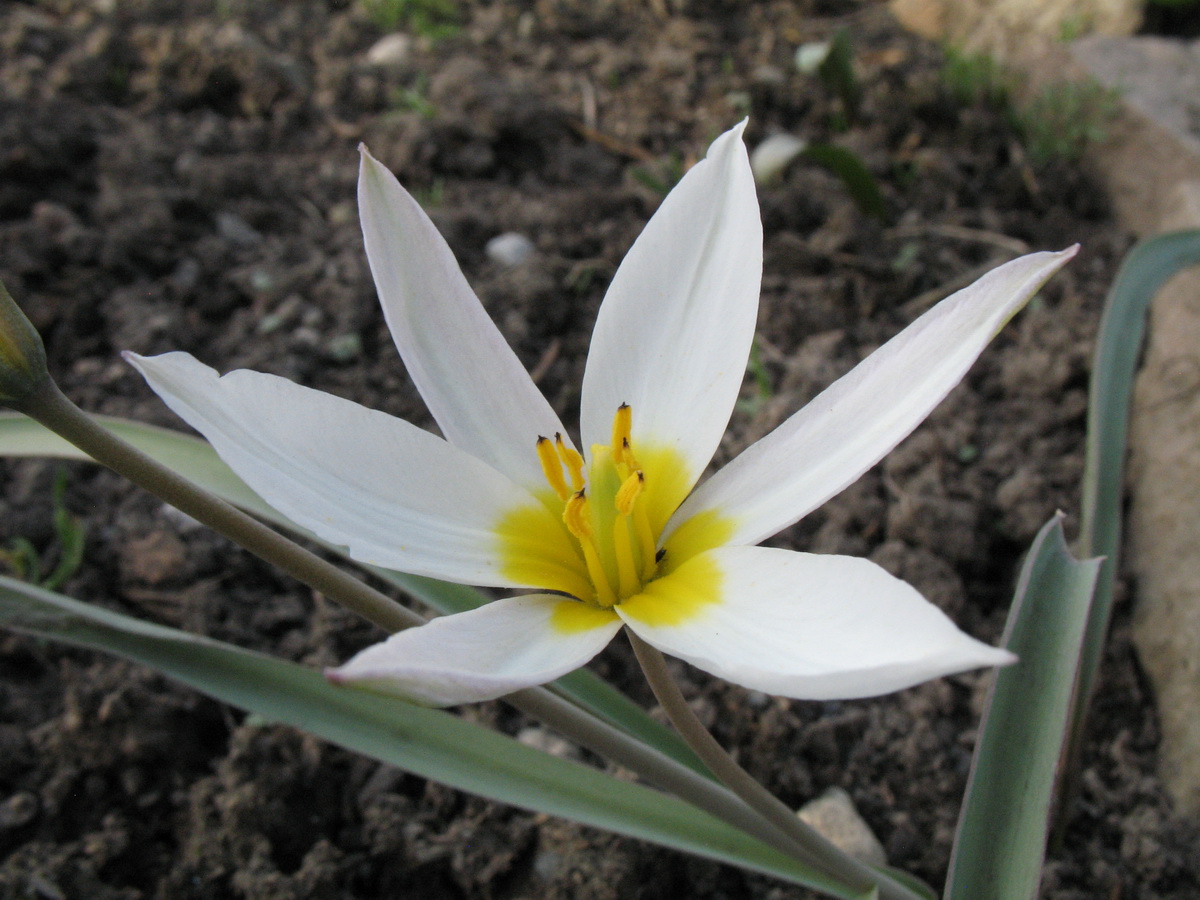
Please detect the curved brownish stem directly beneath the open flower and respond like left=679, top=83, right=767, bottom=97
left=625, top=628, right=918, bottom=900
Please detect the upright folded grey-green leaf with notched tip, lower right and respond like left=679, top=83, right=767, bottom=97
left=946, top=516, right=1100, bottom=900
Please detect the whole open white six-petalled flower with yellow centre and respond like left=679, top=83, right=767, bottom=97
left=130, top=124, right=1074, bottom=706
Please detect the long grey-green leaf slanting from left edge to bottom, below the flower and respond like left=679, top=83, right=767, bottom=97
left=0, top=578, right=860, bottom=899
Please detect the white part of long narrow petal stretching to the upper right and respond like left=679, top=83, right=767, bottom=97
left=668, top=247, right=1078, bottom=544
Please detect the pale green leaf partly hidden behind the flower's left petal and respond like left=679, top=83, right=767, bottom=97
left=0, top=413, right=712, bottom=778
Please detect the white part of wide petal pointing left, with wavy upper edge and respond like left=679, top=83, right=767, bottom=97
left=126, top=353, right=559, bottom=587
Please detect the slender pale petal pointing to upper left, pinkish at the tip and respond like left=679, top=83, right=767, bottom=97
left=359, top=148, right=565, bottom=488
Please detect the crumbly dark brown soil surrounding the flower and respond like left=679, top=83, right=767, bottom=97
left=0, top=0, right=1200, bottom=900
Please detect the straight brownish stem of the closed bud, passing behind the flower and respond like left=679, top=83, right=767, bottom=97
left=10, top=378, right=873, bottom=892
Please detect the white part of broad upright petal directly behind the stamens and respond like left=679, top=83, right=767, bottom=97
left=581, top=122, right=762, bottom=499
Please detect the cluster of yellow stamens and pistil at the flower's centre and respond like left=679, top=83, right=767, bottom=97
left=538, top=403, right=662, bottom=607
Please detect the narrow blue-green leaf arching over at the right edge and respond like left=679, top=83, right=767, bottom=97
left=1069, top=229, right=1200, bottom=758
